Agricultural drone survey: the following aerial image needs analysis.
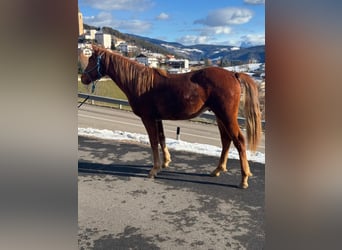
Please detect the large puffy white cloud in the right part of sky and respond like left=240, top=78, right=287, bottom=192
left=194, top=8, right=253, bottom=27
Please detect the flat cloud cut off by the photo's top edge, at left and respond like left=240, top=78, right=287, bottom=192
left=80, top=0, right=153, bottom=11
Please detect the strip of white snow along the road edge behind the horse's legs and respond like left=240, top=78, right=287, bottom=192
left=78, top=128, right=265, bottom=163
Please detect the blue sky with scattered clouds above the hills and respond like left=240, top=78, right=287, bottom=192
left=78, top=0, right=265, bottom=46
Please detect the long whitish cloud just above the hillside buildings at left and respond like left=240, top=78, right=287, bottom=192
left=83, top=12, right=152, bottom=34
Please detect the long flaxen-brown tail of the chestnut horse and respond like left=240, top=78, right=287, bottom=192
left=235, top=73, right=261, bottom=151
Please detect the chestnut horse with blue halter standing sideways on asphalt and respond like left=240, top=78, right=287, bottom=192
left=81, top=45, right=261, bottom=188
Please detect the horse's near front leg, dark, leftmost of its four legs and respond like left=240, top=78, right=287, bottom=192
left=142, top=118, right=160, bottom=178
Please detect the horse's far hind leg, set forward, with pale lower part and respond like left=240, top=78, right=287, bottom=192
left=210, top=119, right=232, bottom=177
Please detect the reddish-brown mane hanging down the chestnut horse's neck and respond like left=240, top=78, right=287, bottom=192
left=99, top=48, right=167, bottom=96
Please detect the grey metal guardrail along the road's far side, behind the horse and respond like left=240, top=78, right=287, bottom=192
left=78, top=93, right=265, bottom=130
